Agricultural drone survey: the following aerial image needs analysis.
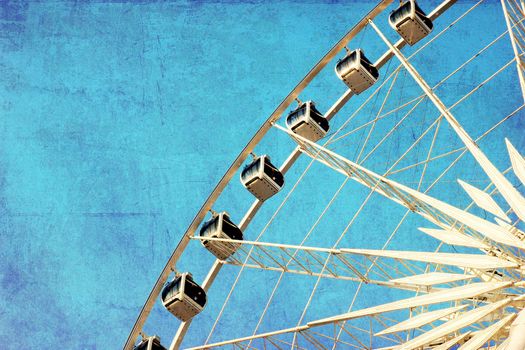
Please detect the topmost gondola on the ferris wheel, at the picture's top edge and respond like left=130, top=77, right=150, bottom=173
left=388, top=0, right=434, bottom=45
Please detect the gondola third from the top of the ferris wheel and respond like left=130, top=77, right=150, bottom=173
left=286, top=101, right=329, bottom=142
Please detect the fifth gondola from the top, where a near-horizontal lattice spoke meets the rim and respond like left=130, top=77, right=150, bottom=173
left=200, top=212, right=242, bottom=260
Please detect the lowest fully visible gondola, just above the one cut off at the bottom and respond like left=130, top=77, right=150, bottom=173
left=161, top=272, right=206, bottom=322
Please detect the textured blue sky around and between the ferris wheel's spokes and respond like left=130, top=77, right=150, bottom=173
left=0, top=0, right=525, bottom=349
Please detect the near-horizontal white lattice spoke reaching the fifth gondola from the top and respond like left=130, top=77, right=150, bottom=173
left=191, top=238, right=518, bottom=290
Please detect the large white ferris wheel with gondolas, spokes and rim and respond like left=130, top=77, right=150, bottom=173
left=125, top=0, right=525, bottom=350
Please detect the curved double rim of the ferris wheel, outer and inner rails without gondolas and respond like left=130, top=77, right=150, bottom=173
left=124, top=0, right=456, bottom=350
